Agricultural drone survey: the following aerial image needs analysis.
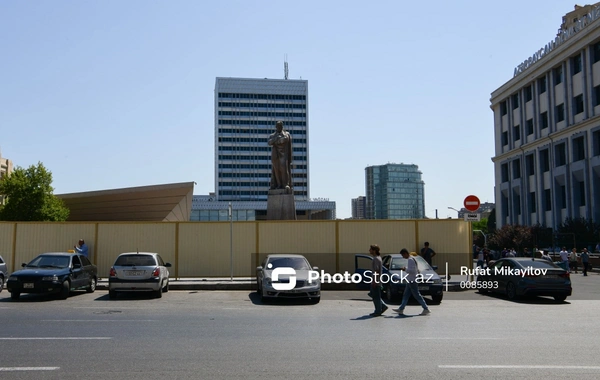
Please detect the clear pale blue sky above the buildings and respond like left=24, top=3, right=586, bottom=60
left=0, top=0, right=575, bottom=218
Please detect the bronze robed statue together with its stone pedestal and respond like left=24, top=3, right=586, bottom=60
left=267, top=121, right=296, bottom=220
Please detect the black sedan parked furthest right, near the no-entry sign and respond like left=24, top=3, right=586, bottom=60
left=475, top=257, right=572, bottom=302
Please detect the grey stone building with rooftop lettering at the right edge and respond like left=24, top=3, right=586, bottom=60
left=491, top=3, right=600, bottom=228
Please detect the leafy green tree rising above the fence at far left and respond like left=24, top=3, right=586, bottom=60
left=0, top=162, right=69, bottom=221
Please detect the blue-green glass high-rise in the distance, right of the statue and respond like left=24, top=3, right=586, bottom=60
left=365, top=164, right=425, bottom=219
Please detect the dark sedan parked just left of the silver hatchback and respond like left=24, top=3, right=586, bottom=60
left=6, top=252, right=98, bottom=300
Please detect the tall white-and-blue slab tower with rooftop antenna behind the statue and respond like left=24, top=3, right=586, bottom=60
left=215, top=78, right=309, bottom=201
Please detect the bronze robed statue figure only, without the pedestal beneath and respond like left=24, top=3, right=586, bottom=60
left=267, top=121, right=292, bottom=194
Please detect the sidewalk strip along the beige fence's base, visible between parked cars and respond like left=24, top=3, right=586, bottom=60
left=96, top=275, right=467, bottom=292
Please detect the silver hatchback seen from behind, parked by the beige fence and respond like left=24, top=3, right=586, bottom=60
left=108, top=252, right=171, bottom=299
